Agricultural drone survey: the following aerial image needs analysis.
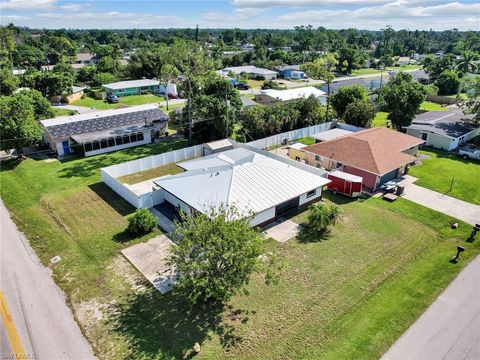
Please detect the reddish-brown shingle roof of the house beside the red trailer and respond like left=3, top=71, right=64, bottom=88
left=304, top=127, right=424, bottom=175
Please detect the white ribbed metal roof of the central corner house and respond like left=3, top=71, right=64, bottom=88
left=154, top=149, right=330, bottom=214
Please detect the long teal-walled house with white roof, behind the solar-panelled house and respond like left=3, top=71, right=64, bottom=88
left=102, top=79, right=177, bottom=96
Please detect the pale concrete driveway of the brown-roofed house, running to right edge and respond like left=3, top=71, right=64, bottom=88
left=401, top=175, right=480, bottom=225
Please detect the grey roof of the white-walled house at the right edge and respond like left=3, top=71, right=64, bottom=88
left=405, top=111, right=479, bottom=138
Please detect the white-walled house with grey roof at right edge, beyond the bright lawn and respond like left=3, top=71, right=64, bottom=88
left=405, top=111, right=480, bottom=151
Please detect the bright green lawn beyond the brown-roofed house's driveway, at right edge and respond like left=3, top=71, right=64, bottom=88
left=410, top=149, right=480, bottom=205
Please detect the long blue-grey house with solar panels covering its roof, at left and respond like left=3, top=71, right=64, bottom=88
left=41, top=104, right=168, bottom=156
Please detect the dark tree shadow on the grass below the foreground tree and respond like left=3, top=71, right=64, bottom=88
left=107, top=288, right=248, bottom=359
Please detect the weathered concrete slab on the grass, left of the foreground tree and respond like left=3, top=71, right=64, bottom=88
left=121, top=235, right=175, bottom=294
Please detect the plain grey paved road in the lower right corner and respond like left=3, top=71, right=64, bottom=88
left=382, top=256, right=480, bottom=360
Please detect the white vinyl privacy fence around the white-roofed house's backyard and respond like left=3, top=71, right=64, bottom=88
left=100, top=122, right=362, bottom=209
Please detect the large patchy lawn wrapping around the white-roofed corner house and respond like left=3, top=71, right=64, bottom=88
left=0, top=140, right=479, bottom=359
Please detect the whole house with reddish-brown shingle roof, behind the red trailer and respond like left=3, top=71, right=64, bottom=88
left=303, top=127, right=424, bottom=191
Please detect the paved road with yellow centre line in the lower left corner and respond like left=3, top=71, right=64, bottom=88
left=0, top=201, right=95, bottom=360
